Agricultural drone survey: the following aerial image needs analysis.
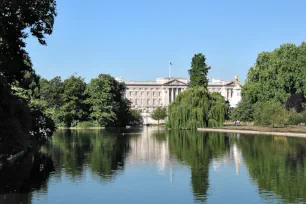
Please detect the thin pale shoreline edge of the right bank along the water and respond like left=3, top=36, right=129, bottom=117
left=197, top=128, right=306, bottom=138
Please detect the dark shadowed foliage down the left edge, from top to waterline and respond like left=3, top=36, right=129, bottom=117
left=0, top=0, right=56, bottom=153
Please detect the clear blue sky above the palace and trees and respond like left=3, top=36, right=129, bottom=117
left=27, top=0, right=306, bottom=81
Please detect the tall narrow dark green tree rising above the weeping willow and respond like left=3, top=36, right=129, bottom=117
left=188, top=53, right=210, bottom=88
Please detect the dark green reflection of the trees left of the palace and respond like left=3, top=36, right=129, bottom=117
left=44, top=130, right=128, bottom=180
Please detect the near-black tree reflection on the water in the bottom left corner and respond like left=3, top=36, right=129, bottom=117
left=0, top=152, right=54, bottom=203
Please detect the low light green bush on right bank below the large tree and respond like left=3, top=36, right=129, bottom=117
left=254, top=100, right=288, bottom=127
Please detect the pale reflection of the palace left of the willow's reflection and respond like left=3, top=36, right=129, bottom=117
left=127, top=128, right=170, bottom=171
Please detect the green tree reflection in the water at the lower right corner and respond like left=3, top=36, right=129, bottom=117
left=239, top=136, right=306, bottom=203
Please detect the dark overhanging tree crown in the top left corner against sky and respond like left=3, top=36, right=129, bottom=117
left=0, top=0, right=56, bottom=83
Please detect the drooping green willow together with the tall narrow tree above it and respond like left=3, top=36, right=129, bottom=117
left=168, top=54, right=228, bottom=129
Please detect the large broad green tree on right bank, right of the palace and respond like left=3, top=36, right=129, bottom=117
left=237, top=42, right=306, bottom=119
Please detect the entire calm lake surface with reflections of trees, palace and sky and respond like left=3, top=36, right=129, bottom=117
left=0, top=128, right=306, bottom=204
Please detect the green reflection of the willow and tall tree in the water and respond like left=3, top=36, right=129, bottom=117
left=168, top=131, right=229, bottom=202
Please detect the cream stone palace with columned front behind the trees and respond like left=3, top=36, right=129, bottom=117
left=117, top=76, right=241, bottom=113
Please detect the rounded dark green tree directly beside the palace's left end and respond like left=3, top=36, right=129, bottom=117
left=86, top=74, right=129, bottom=127
